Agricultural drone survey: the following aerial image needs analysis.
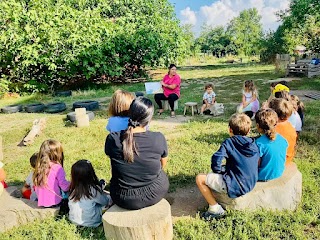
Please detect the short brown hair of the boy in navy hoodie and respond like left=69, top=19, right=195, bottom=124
left=229, top=113, right=251, bottom=136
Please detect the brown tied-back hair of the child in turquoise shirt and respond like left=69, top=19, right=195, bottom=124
left=255, top=108, right=278, bottom=141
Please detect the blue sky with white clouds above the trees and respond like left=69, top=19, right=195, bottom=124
left=169, top=0, right=290, bottom=35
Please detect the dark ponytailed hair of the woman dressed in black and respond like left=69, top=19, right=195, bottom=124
left=122, top=97, right=154, bottom=163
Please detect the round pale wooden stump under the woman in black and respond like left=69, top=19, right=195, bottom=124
left=102, top=199, right=173, bottom=240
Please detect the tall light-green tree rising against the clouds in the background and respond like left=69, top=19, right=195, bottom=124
left=227, top=8, right=262, bottom=56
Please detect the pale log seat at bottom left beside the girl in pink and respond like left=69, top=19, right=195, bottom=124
left=0, top=187, right=59, bottom=232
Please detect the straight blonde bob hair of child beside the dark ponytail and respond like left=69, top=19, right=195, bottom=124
left=109, top=89, right=134, bottom=117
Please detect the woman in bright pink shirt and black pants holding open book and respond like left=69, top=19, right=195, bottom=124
left=154, top=64, right=181, bottom=117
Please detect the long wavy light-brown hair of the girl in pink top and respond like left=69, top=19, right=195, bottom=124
left=33, top=139, right=64, bottom=186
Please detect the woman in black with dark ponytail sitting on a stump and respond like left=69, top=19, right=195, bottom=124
left=105, top=97, right=169, bottom=210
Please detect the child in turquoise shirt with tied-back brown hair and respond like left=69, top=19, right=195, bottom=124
left=255, top=108, right=288, bottom=181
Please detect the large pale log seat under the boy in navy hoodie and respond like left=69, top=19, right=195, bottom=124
left=213, top=163, right=302, bottom=210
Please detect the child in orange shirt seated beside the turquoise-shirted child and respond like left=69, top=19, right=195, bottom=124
left=269, top=98, right=297, bottom=165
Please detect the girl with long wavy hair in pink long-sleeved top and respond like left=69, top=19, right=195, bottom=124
left=33, top=139, right=70, bottom=207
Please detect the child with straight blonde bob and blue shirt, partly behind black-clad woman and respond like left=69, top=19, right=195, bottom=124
left=106, top=90, right=134, bottom=132
